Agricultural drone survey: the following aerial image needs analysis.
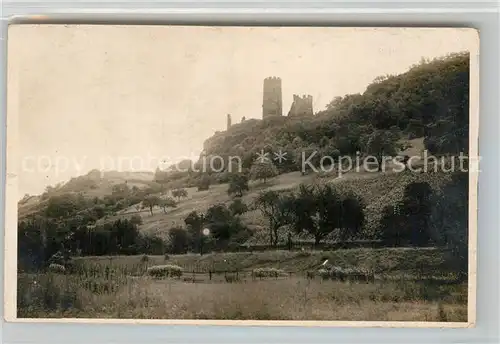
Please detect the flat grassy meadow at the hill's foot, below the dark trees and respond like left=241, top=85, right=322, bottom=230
left=18, top=249, right=467, bottom=322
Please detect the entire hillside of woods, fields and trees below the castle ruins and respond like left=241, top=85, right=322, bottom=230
left=18, top=53, right=469, bottom=269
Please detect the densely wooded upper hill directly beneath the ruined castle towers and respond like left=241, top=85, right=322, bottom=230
left=204, top=52, right=469, bottom=168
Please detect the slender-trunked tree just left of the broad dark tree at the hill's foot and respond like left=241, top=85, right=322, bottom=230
left=254, top=191, right=294, bottom=246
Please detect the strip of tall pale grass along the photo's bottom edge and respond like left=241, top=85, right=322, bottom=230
left=18, top=274, right=467, bottom=321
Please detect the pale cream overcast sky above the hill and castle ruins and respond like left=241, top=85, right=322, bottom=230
left=8, top=25, right=477, bottom=195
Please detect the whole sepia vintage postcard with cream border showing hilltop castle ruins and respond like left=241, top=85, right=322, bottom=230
left=5, top=24, right=479, bottom=327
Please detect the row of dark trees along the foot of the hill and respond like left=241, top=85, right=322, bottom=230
left=18, top=172, right=468, bottom=276
